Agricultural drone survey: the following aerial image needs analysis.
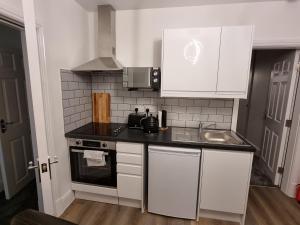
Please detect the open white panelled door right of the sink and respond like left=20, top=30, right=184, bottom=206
left=261, top=57, right=294, bottom=185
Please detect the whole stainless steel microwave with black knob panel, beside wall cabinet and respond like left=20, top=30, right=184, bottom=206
left=123, top=67, right=161, bottom=90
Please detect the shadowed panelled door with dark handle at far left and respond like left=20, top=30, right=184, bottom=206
left=0, top=49, right=34, bottom=199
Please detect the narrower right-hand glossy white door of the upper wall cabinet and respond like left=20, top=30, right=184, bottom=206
left=217, top=26, right=253, bottom=97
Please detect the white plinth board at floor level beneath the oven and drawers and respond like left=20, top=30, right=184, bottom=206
left=75, top=191, right=141, bottom=208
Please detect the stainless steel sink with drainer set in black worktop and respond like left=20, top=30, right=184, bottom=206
left=172, top=127, right=244, bottom=145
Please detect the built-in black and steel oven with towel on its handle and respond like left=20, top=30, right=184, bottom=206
left=68, top=139, right=117, bottom=188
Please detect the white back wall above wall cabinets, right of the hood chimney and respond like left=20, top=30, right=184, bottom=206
left=116, top=1, right=300, bottom=66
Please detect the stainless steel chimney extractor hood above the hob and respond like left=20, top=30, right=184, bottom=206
left=72, top=5, right=123, bottom=72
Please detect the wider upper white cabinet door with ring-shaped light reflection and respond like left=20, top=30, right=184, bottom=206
left=161, top=27, right=221, bottom=97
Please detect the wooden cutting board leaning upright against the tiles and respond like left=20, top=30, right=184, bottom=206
left=93, top=93, right=110, bottom=123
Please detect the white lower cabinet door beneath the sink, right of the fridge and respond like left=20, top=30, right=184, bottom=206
left=200, top=149, right=253, bottom=214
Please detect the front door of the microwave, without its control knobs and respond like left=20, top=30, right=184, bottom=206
left=128, top=68, right=151, bottom=88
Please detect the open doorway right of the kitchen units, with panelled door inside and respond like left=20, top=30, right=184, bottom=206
left=237, top=49, right=297, bottom=186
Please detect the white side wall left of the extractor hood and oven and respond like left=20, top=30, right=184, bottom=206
left=31, top=0, right=90, bottom=215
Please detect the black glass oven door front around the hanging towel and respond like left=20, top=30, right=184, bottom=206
left=70, top=148, right=117, bottom=187
